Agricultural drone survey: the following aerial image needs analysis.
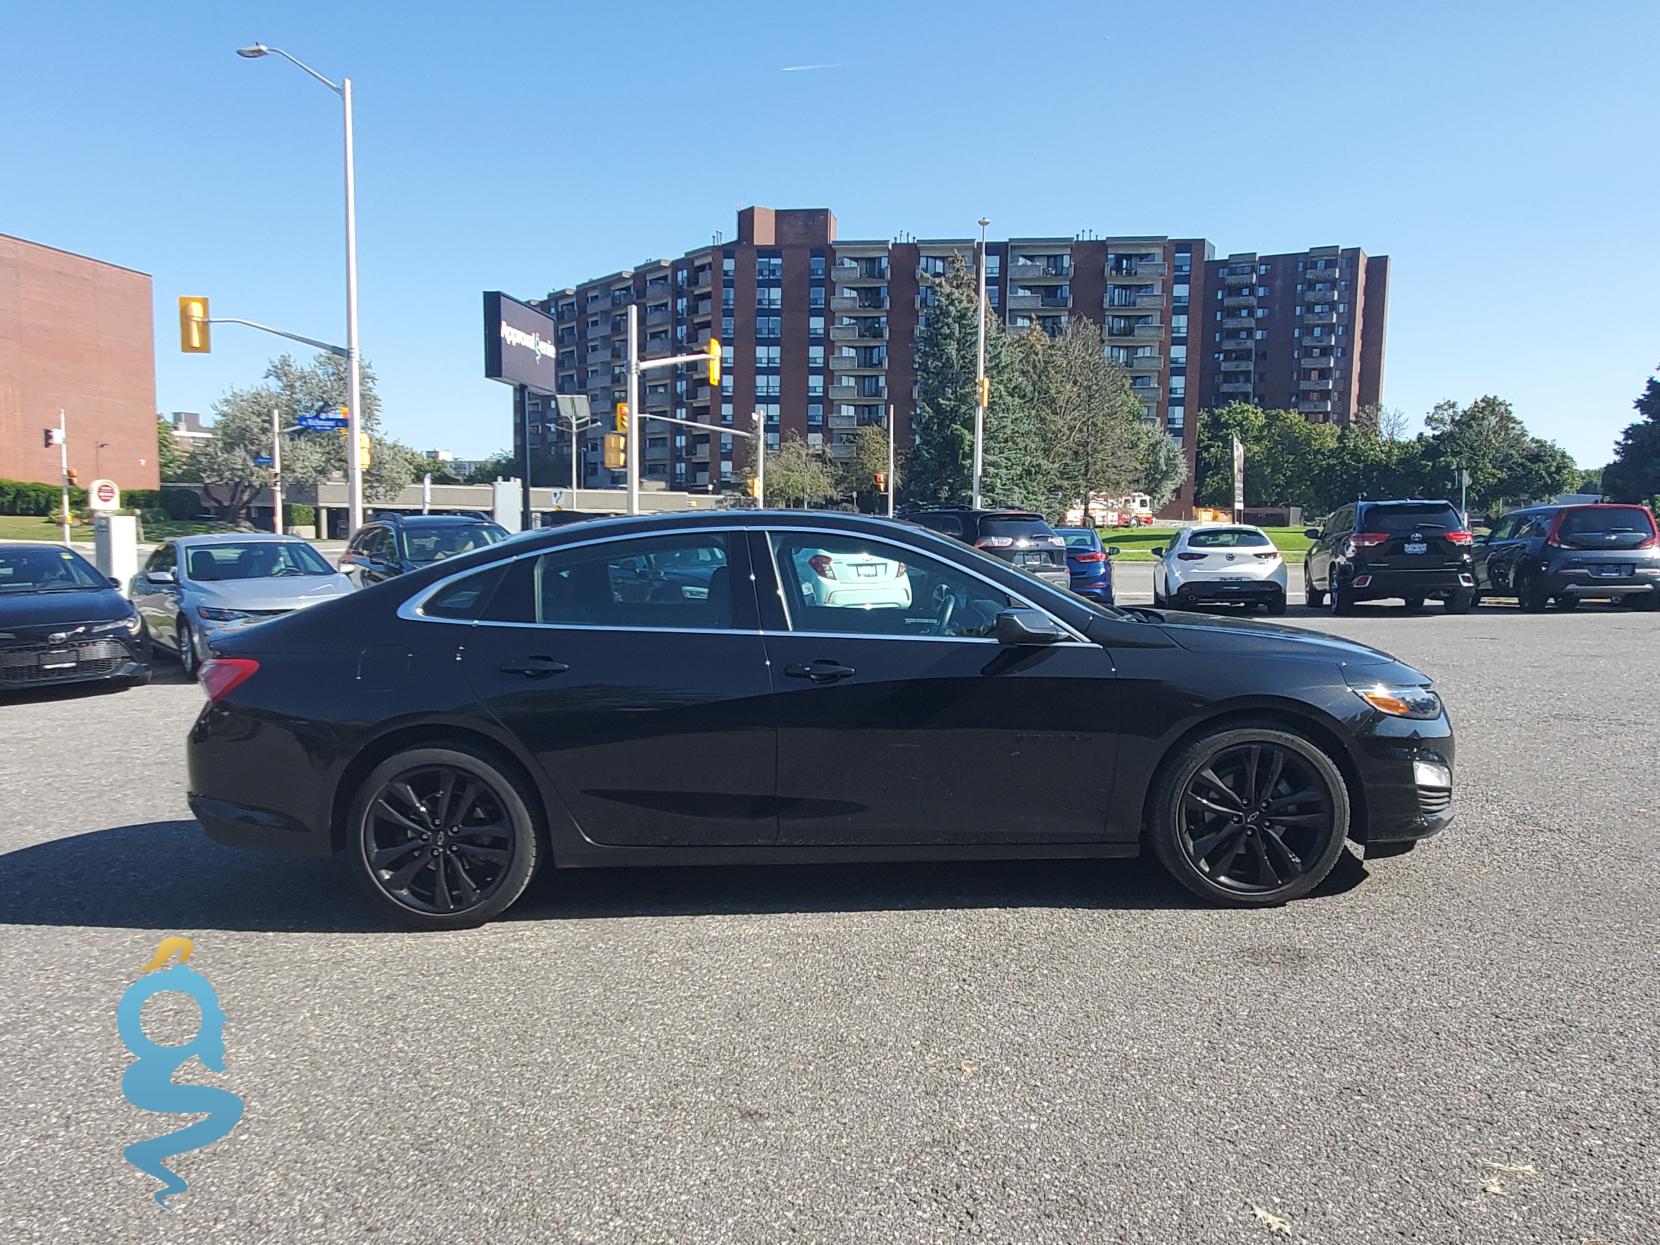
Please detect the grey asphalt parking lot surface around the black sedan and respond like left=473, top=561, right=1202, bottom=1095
left=0, top=600, right=1660, bottom=1243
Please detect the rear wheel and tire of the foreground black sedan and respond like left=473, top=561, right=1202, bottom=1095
left=344, top=744, right=541, bottom=930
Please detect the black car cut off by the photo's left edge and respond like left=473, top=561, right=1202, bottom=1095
left=0, top=544, right=149, bottom=691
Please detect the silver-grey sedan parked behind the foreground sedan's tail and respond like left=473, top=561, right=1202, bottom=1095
left=128, top=533, right=352, bottom=679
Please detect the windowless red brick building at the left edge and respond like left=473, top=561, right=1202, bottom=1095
left=0, top=234, right=159, bottom=488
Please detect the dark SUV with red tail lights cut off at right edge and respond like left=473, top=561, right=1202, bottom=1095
left=1476, top=506, right=1660, bottom=613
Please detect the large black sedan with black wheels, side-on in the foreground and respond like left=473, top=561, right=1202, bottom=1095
left=189, top=511, right=1453, bottom=928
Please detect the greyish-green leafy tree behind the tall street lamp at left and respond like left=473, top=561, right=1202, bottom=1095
left=194, top=354, right=417, bottom=521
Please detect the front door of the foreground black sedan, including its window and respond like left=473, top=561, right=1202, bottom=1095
left=752, top=531, right=1119, bottom=845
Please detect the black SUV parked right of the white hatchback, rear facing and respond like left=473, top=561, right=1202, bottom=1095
left=1303, top=498, right=1476, bottom=614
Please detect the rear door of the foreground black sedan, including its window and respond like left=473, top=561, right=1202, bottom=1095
left=461, top=533, right=779, bottom=847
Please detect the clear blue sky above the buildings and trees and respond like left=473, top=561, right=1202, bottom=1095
left=0, top=0, right=1660, bottom=466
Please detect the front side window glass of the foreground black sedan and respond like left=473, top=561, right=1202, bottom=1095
left=769, top=531, right=1014, bottom=639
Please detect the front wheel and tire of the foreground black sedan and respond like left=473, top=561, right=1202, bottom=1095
left=1145, top=724, right=1350, bottom=908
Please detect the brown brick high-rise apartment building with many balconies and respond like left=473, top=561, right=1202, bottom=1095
left=515, top=208, right=1388, bottom=515
